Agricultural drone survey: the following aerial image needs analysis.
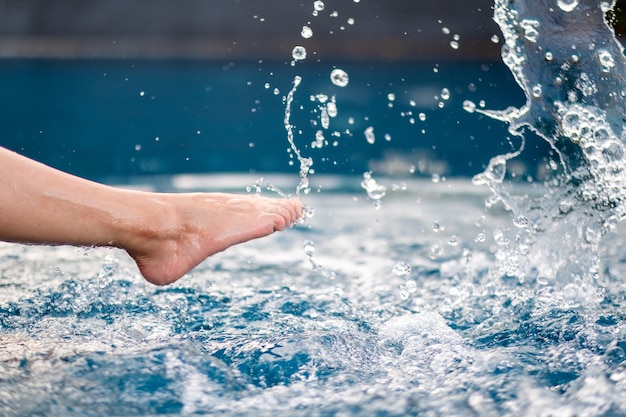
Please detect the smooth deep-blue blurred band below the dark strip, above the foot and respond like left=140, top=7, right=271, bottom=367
left=0, top=59, right=547, bottom=180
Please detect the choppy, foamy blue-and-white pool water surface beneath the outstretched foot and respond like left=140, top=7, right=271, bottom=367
left=0, top=176, right=626, bottom=416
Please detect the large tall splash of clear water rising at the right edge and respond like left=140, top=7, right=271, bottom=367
left=466, top=0, right=626, bottom=299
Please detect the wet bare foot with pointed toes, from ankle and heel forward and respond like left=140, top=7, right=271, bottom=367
left=120, top=193, right=302, bottom=285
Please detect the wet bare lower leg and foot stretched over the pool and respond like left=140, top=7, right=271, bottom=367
left=0, top=148, right=302, bottom=285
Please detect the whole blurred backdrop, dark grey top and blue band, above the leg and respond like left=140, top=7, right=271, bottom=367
left=0, top=0, right=623, bottom=180
